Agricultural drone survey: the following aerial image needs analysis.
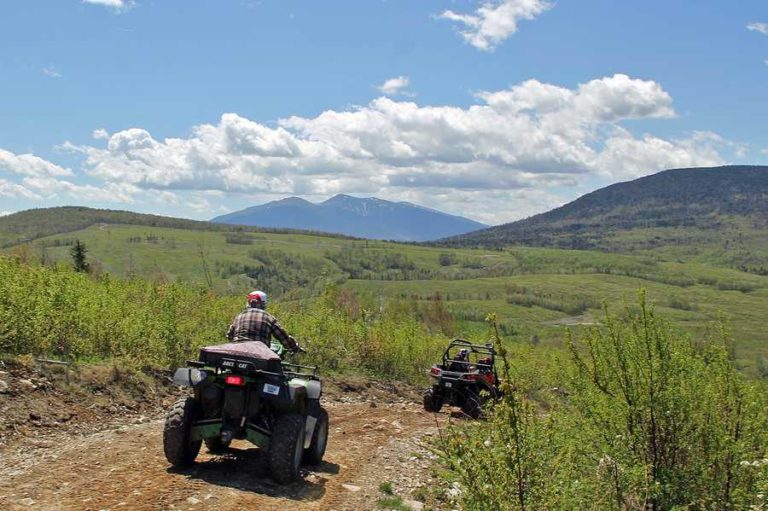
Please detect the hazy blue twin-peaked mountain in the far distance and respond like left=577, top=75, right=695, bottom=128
left=212, top=195, right=486, bottom=241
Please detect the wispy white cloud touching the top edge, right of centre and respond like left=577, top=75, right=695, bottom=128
left=439, top=0, right=552, bottom=51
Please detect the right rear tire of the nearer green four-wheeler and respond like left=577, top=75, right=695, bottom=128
left=269, top=413, right=306, bottom=484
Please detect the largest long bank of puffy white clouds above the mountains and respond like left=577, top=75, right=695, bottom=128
left=52, top=74, right=728, bottom=221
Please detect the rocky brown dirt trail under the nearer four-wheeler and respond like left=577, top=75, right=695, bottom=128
left=0, top=402, right=445, bottom=511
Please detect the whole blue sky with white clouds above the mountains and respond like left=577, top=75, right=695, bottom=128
left=0, top=0, right=768, bottom=223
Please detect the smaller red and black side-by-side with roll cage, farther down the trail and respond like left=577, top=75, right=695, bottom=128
left=424, top=339, right=501, bottom=419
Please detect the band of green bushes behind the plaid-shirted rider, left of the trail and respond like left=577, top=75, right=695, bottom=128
left=0, top=257, right=446, bottom=380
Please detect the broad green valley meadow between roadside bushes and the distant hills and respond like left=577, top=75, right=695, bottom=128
left=10, top=224, right=768, bottom=371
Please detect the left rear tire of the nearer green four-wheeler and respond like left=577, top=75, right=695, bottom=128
left=163, top=397, right=203, bottom=467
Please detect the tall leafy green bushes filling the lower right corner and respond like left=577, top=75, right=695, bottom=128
left=439, top=295, right=768, bottom=510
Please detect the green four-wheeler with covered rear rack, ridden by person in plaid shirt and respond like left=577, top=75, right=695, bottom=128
left=163, top=341, right=328, bottom=484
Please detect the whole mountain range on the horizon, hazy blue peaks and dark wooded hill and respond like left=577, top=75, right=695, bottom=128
left=0, top=165, right=768, bottom=256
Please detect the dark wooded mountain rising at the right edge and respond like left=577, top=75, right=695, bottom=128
left=441, top=166, right=768, bottom=255
